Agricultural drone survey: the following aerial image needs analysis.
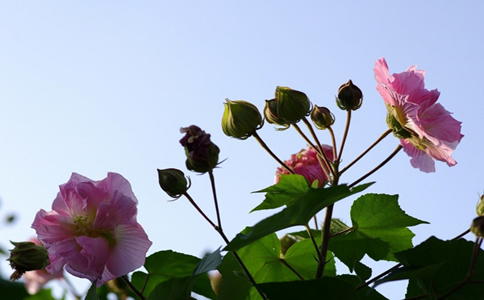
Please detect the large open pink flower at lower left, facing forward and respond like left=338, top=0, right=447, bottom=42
left=32, top=173, right=151, bottom=286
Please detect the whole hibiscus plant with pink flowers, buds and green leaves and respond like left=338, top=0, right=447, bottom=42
left=5, top=58, right=484, bottom=300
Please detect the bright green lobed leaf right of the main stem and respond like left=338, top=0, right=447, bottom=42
left=329, top=194, right=427, bottom=271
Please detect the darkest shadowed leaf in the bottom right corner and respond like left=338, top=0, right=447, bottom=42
left=390, top=237, right=484, bottom=299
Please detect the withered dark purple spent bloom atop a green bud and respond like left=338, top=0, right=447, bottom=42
left=180, top=125, right=220, bottom=173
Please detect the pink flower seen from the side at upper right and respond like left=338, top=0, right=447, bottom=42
left=373, top=58, right=463, bottom=173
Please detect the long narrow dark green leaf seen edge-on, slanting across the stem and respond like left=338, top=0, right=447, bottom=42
left=225, top=183, right=371, bottom=251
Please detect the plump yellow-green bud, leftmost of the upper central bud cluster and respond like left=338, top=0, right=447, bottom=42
left=222, top=99, right=264, bottom=140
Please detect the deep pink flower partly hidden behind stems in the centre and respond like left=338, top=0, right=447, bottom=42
left=275, top=145, right=333, bottom=187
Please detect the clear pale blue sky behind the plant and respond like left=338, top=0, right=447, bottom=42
left=0, top=1, right=484, bottom=299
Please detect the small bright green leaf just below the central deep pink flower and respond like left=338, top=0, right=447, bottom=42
left=251, top=174, right=310, bottom=212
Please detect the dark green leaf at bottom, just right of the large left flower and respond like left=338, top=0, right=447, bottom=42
left=132, top=250, right=217, bottom=299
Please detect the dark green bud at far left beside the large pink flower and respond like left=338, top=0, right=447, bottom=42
left=7, top=241, right=49, bottom=281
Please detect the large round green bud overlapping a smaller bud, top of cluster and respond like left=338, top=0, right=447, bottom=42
left=276, top=86, right=311, bottom=124
